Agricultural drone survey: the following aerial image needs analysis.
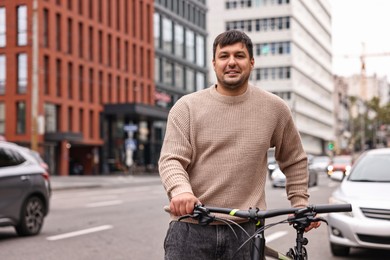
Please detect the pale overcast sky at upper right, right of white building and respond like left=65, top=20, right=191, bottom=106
left=329, top=0, right=390, bottom=81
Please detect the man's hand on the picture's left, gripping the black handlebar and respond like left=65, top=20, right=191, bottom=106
left=169, top=192, right=202, bottom=216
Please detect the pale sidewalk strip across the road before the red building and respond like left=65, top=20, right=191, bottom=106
left=50, top=173, right=161, bottom=191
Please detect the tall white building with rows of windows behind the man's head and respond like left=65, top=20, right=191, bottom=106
left=207, top=0, right=334, bottom=154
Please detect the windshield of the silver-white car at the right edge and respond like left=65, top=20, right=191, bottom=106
left=349, top=154, right=390, bottom=182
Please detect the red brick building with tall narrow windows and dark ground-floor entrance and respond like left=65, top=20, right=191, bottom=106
left=0, top=0, right=167, bottom=175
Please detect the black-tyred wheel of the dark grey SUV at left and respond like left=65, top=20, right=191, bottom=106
left=15, top=196, right=45, bottom=236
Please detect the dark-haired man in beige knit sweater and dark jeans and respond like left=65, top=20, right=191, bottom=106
left=159, top=30, right=319, bottom=260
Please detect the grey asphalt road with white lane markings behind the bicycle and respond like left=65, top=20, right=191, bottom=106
left=0, top=176, right=388, bottom=260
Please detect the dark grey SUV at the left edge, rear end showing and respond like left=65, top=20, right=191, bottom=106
left=0, top=141, right=51, bottom=236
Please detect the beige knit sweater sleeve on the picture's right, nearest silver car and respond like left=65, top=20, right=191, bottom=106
left=275, top=112, right=309, bottom=207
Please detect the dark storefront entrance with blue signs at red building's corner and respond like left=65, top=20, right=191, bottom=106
left=99, top=104, right=168, bottom=174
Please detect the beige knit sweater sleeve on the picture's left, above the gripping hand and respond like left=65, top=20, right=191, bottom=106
left=159, top=100, right=193, bottom=199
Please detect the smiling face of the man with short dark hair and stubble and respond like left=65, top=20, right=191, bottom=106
left=213, top=42, right=255, bottom=90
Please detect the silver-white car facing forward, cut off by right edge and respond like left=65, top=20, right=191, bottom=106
left=327, top=148, right=390, bottom=256
